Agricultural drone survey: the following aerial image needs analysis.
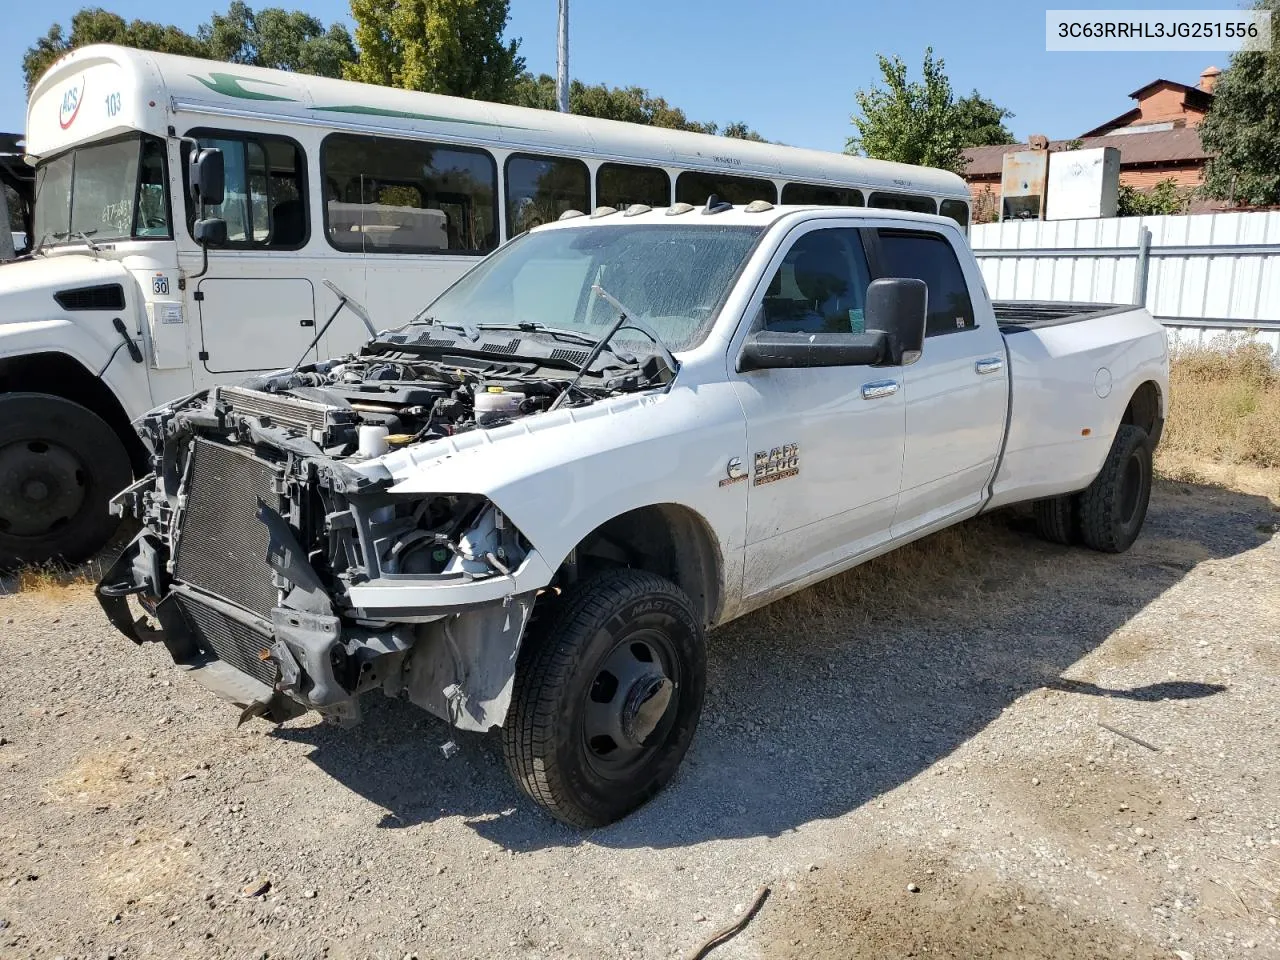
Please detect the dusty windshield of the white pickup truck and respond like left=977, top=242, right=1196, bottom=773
left=422, top=224, right=764, bottom=351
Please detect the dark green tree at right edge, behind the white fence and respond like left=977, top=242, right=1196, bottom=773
left=1199, top=0, right=1280, bottom=204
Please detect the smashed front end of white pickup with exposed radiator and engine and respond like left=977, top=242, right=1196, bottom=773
left=97, top=361, right=553, bottom=731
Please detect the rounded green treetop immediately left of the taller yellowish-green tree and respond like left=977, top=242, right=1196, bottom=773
left=198, top=0, right=356, bottom=77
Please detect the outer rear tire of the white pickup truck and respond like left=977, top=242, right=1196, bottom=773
left=1078, top=424, right=1151, bottom=553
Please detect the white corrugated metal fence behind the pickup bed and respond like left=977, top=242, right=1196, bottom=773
left=970, top=211, right=1280, bottom=357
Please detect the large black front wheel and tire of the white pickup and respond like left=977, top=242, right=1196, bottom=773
left=503, top=570, right=707, bottom=827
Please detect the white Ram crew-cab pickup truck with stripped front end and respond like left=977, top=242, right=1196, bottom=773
left=99, top=197, right=1167, bottom=826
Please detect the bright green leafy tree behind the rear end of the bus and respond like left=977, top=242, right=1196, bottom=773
left=845, top=47, right=1012, bottom=172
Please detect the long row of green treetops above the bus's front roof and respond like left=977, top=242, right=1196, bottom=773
left=22, top=0, right=356, bottom=93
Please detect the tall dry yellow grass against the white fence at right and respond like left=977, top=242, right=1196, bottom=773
left=1160, top=335, right=1280, bottom=480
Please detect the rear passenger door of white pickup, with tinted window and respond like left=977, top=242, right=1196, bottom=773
left=874, top=227, right=1009, bottom=536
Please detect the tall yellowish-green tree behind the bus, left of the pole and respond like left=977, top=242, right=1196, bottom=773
left=343, top=0, right=525, bottom=101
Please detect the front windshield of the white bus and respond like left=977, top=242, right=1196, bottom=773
left=35, top=137, right=172, bottom=246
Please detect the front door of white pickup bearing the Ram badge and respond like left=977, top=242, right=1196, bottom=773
left=732, top=221, right=906, bottom=598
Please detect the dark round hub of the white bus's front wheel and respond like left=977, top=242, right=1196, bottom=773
left=0, top=440, right=86, bottom=536
